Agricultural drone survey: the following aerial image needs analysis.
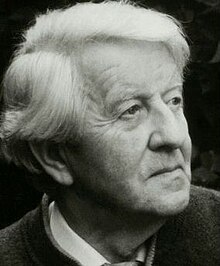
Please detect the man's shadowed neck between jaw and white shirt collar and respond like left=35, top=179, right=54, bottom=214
left=57, top=188, right=165, bottom=263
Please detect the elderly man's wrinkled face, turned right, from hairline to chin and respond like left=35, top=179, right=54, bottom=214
left=70, top=42, right=191, bottom=216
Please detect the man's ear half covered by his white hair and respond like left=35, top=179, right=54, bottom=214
left=29, top=143, right=73, bottom=186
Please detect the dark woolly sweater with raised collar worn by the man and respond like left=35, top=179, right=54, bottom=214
left=0, top=187, right=220, bottom=266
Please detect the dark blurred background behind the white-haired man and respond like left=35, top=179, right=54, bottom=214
left=0, top=0, right=220, bottom=228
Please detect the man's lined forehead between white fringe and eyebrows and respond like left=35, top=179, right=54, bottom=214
left=82, top=41, right=182, bottom=99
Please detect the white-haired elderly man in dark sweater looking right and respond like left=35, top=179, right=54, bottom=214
left=0, top=2, right=220, bottom=266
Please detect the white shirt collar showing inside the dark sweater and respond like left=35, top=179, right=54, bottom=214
left=49, top=202, right=146, bottom=266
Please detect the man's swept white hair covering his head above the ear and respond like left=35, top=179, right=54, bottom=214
left=0, top=1, right=189, bottom=174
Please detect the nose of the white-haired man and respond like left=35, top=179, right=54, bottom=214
left=148, top=107, right=188, bottom=150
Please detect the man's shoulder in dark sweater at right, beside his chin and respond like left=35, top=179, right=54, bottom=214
left=157, top=186, right=220, bottom=266
